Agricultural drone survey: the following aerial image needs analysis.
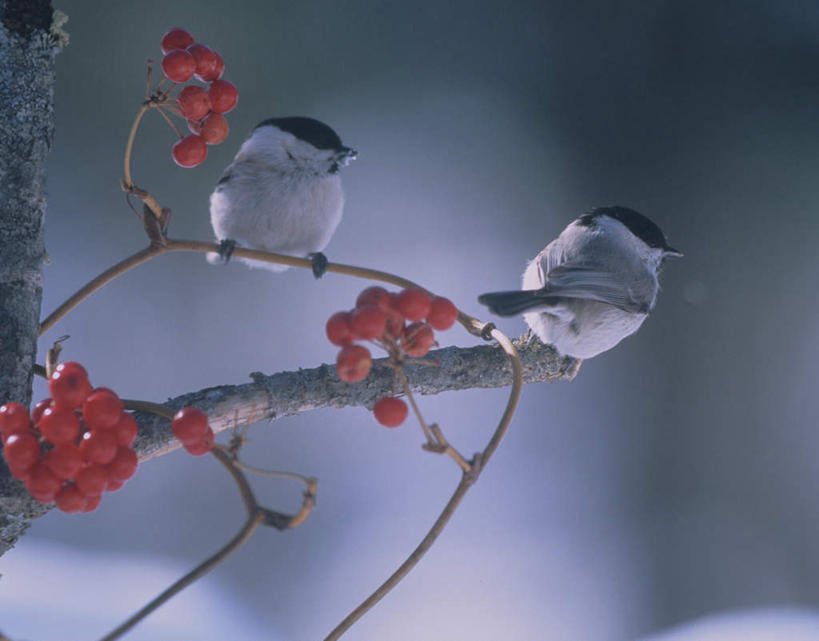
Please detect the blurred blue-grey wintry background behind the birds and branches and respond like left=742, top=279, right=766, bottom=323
left=0, top=0, right=819, bottom=641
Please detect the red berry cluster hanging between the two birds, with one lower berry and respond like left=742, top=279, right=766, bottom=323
left=326, top=287, right=458, bottom=427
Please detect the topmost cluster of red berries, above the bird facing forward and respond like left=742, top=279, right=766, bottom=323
left=160, top=27, right=239, bottom=167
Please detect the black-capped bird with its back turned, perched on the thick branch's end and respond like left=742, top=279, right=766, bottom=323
left=478, top=207, right=682, bottom=358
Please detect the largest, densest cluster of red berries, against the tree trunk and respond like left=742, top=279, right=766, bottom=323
left=0, top=361, right=137, bottom=512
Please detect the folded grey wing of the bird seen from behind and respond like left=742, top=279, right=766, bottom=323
left=541, top=263, right=653, bottom=314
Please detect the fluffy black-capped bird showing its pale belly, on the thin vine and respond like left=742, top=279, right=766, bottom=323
left=208, top=116, right=358, bottom=278
